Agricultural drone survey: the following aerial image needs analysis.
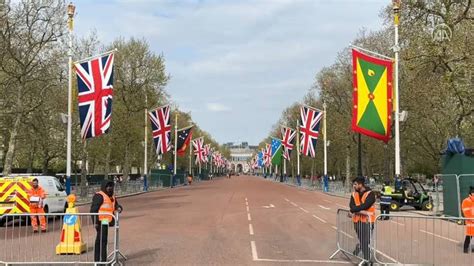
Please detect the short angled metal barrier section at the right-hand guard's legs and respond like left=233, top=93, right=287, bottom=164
left=330, top=209, right=373, bottom=265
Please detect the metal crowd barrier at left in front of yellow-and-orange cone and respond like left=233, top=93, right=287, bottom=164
left=0, top=213, right=121, bottom=265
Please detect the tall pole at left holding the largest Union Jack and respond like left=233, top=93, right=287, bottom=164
left=66, top=2, right=76, bottom=195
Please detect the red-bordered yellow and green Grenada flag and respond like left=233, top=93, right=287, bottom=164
left=352, top=49, right=392, bottom=142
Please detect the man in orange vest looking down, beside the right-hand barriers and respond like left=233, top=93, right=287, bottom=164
left=349, top=177, right=375, bottom=261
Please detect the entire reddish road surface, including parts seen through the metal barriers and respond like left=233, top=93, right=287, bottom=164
left=0, top=176, right=474, bottom=265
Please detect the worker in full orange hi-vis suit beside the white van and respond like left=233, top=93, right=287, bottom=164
left=28, top=178, right=46, bottom=233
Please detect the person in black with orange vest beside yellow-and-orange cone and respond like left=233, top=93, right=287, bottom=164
left=90, top=180, right=122, bottom=262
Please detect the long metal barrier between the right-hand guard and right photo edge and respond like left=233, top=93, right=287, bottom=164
left=374, top=214, right=474, bottom=265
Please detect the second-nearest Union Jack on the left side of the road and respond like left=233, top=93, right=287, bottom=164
left=148, top=105, right=171, bottom=155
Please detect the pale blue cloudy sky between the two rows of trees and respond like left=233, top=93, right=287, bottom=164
left=75, top=0, right=391, bottom=144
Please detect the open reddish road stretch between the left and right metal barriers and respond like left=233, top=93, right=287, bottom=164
left=115, top=176, right=354, bottom=265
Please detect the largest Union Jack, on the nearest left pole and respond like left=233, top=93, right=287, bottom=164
left=74, top=53, right=114, bottom=139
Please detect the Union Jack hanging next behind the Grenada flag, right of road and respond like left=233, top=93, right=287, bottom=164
left=300, top=106, right=323, bottom=157
